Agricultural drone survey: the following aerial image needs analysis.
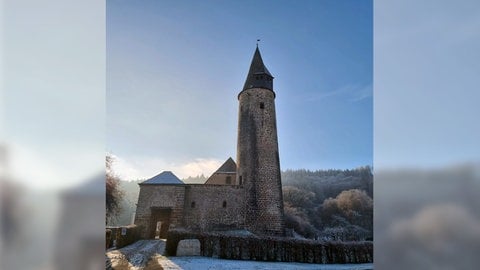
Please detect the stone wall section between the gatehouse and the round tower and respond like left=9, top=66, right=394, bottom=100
left=183, top=185, right=245, bottom=231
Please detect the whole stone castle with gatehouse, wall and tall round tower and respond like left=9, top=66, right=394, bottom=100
left=135, top=46, right=285, bottom=238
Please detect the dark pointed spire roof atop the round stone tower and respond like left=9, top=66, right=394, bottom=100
left=243, top=46, right=273, bottom=91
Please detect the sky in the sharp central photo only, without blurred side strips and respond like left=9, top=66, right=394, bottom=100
left=106, top=1, right=373, bottom=178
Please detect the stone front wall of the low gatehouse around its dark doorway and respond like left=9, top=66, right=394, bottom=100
left=135, top=185, right=185, bottom=239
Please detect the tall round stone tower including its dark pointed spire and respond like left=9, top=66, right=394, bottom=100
left=237, top=45, right=285, bottom=236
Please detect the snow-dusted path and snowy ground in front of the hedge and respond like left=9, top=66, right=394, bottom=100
left=106, top=240, right=373, bottom=270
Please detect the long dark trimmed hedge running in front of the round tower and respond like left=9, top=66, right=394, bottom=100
left=165, top=230, right=373, bottom=264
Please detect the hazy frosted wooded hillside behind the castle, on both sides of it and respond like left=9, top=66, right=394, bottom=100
left=109, top=166, right=373, bottom=241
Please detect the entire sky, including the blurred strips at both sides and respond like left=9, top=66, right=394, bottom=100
left=0, top=0, right=480, bottom=189
